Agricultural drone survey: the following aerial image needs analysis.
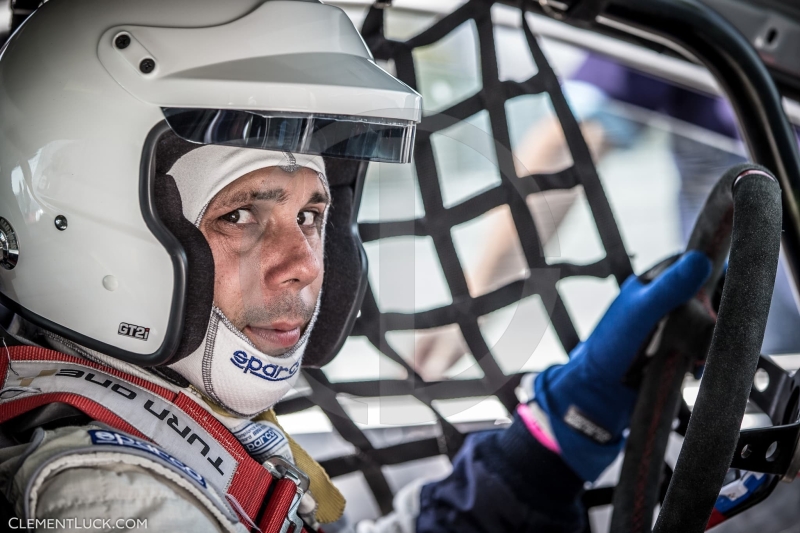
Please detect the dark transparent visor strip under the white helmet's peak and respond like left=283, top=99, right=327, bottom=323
left=163, top=108, right=416, bottom=163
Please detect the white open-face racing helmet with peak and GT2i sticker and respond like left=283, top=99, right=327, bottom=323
left=0, top=0, right=421, bottom=366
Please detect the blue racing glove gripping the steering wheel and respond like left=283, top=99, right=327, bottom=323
left=534, top=251, right=711, bottom=481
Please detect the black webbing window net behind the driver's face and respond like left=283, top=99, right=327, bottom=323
left=277, top=0, right=632, bottom=513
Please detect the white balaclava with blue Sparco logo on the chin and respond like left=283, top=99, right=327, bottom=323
left=168, top=145, right=328, bottom=418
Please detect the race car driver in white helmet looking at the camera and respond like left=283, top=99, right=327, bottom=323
left=0, top=0, right=710, bottom=532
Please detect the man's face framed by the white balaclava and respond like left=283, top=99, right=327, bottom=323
left=200, top=167, right=329, bottom=355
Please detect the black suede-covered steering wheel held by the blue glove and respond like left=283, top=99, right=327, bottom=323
left=611, top=164, right=780, bottom=533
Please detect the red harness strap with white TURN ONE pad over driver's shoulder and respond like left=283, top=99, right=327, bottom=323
left=0, top=346, right=305, bottom=533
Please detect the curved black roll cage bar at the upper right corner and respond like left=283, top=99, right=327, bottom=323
left=516, top=0, right=800, bottom=300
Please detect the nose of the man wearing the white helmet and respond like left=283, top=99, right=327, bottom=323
left=262, top=226, right=322, bottom=290
